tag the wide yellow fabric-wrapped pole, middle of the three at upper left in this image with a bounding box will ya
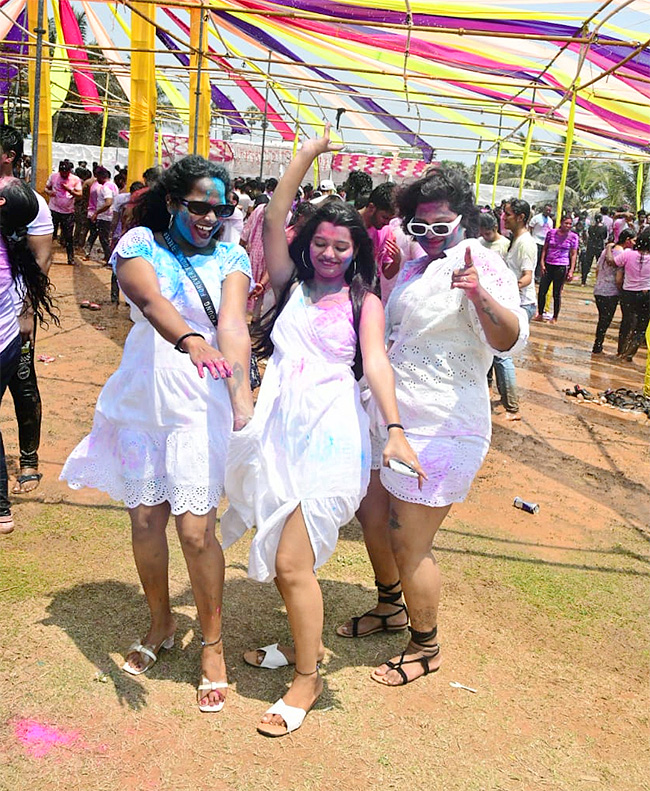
[129,2,157,180]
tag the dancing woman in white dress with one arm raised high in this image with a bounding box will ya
[221,127,420,736]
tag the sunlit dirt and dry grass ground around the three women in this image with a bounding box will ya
[0,254,650,791]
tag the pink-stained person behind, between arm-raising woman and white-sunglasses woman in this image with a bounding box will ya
[359,181,402,305]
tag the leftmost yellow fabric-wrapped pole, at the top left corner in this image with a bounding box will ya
[27,0,52,192]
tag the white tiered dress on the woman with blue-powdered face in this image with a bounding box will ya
[61,227,251,515]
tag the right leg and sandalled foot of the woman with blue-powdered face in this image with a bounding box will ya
[176,508,226,706]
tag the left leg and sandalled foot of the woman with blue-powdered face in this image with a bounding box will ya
[126,503,176,670]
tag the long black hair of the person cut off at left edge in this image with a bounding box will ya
[0,178,59,327]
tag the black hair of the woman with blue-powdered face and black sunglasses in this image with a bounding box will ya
[133,154,230,232]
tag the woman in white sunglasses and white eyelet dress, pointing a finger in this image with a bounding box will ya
[337,167,528,686]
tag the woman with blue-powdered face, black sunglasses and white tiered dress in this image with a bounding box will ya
[61,156,253,711]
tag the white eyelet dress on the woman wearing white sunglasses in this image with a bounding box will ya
[368,239,528,507]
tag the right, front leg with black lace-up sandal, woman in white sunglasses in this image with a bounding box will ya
[374,497,451,686]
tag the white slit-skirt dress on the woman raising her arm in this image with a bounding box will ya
[221,285,370,582]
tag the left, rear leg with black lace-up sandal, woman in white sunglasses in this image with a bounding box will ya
[337,470,408,637]
